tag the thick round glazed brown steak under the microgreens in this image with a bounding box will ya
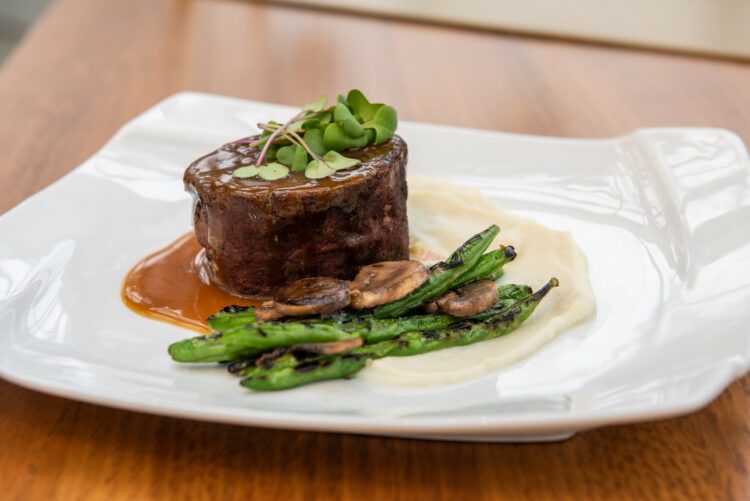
[184,136,409,297]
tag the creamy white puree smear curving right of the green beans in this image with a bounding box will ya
[357,177,596,386]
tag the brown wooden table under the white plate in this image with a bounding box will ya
[0,0,750,500]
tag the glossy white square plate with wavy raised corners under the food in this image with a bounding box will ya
[0,93,750,441]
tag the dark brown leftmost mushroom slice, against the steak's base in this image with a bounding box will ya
[255,277,349,321]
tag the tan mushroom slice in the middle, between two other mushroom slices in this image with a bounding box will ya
[349,260,429,310]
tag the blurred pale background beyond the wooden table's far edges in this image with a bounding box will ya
[0,0,750,61]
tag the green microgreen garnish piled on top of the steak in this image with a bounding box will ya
[233,89,398,181]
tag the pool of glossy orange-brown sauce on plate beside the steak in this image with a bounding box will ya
[121,232,261,333]
